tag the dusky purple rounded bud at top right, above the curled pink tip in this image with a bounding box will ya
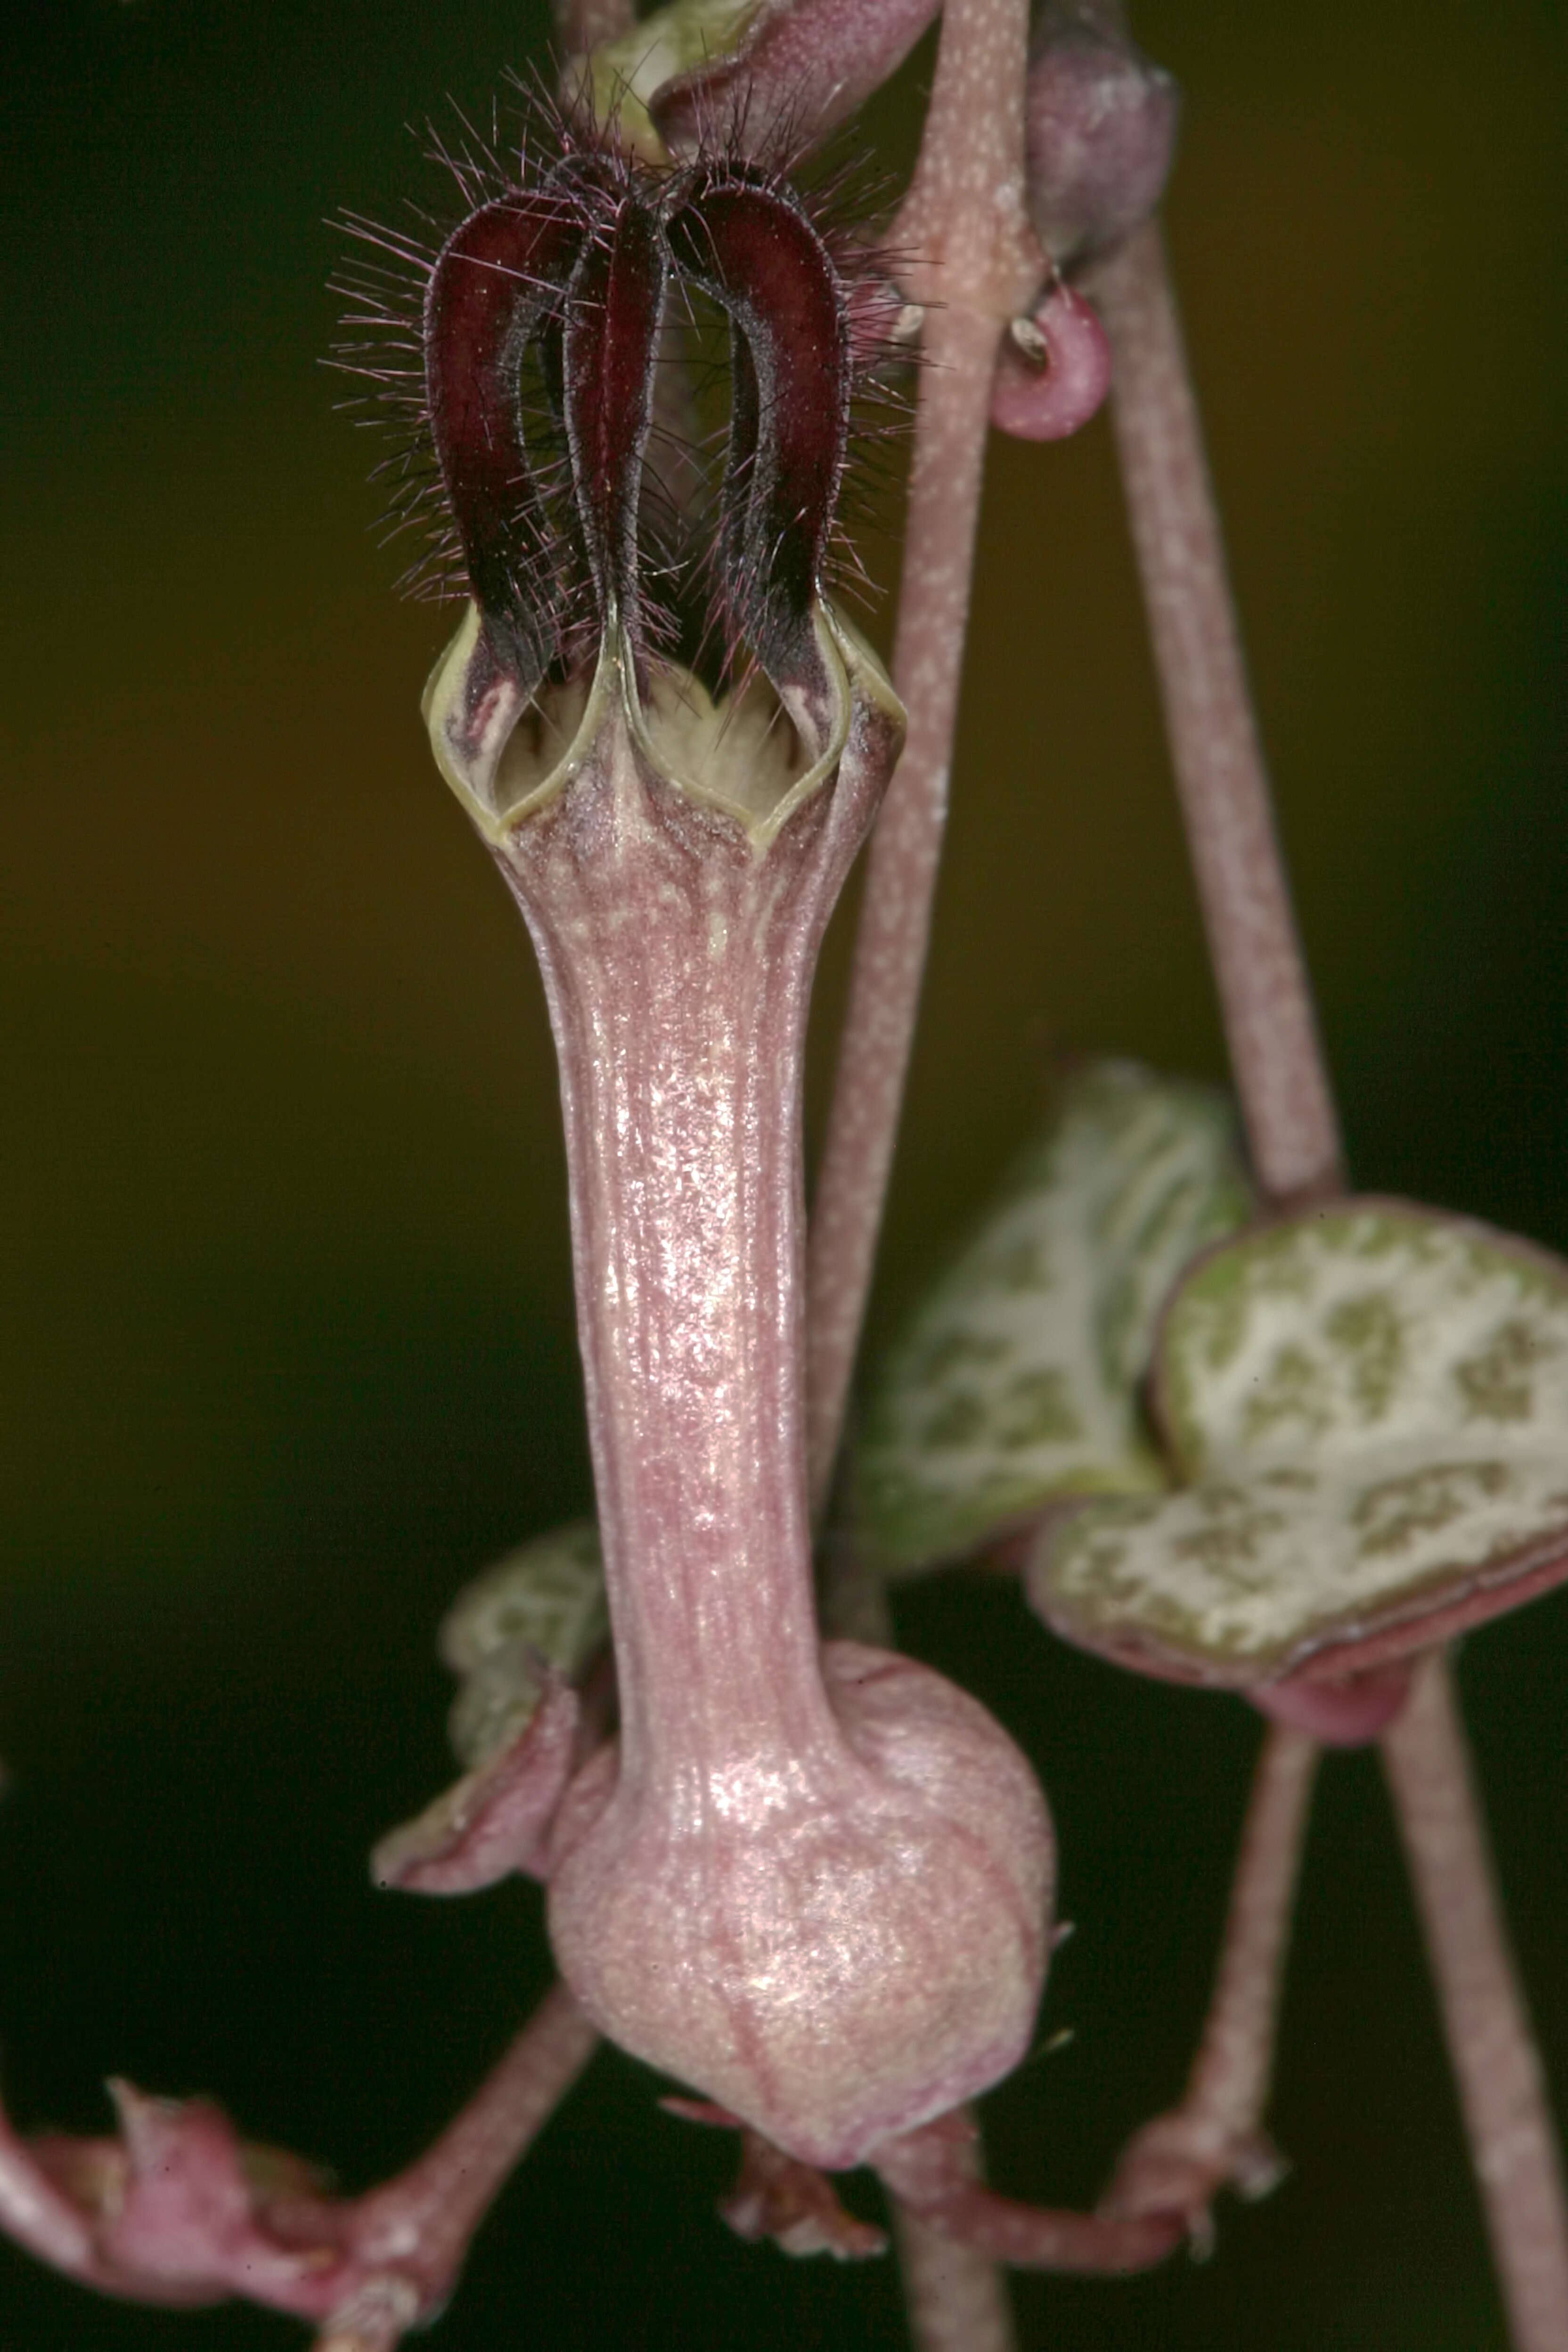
[1025,0,1180,266]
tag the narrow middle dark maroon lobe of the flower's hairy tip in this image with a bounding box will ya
[564,195,665,630]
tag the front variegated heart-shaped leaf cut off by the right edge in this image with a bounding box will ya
[1027,1200,1568,1686]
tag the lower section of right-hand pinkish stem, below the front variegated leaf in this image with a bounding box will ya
[1382,1651,1568,2352]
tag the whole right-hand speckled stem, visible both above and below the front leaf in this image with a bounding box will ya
[1093,212,1568,2352]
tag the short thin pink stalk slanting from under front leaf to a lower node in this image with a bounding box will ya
[1107,1724,1319,2248]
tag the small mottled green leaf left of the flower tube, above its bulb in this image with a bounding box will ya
[440,1519,609,1769]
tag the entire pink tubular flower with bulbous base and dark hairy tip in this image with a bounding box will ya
[425,129,1051,2169]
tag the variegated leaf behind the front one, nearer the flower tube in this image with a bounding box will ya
[853,1061,1248,1576]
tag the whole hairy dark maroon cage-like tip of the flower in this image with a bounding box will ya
[421,127,884,823]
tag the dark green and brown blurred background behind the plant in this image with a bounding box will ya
[0,0,1568,2352]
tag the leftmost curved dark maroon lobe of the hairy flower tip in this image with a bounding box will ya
[425,186,595,694]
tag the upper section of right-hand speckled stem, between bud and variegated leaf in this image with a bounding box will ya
[1093,223,1340,1204]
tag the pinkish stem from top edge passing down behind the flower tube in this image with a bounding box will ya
[806,0,1044,1515]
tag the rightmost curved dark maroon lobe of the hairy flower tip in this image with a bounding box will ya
[668,167,853,678]
